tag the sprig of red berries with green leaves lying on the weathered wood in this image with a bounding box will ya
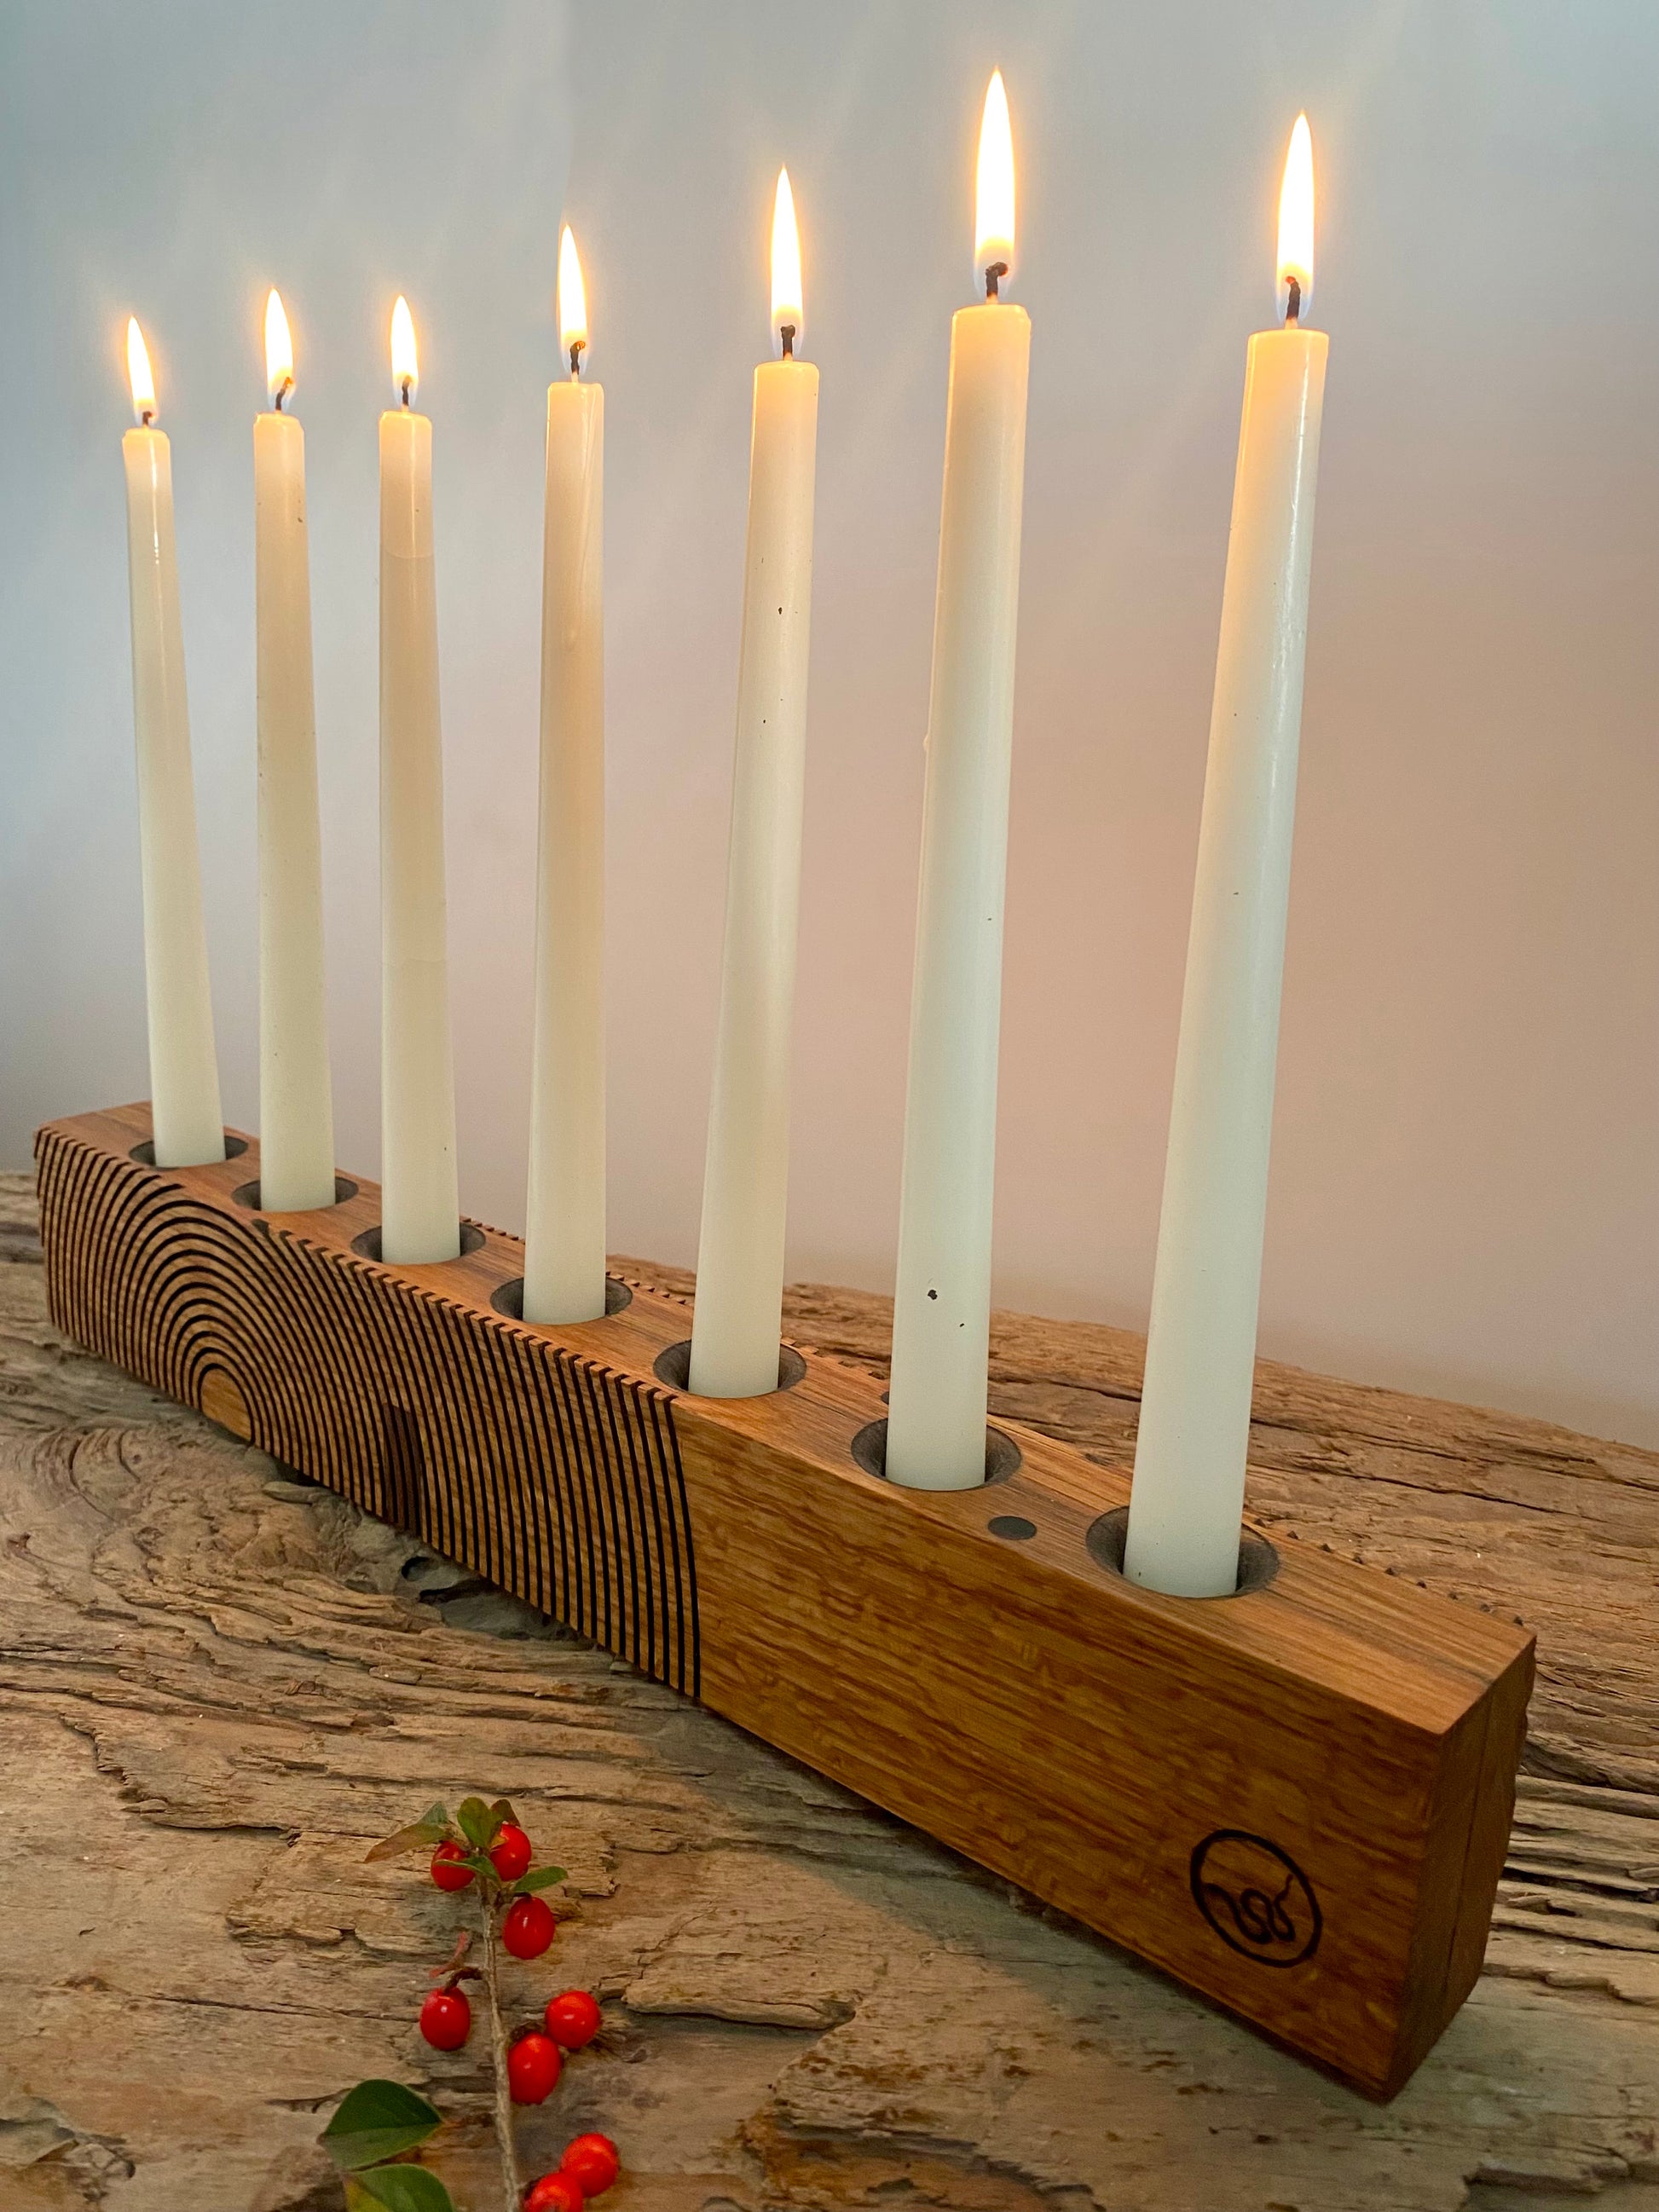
[323,1796,620,2212]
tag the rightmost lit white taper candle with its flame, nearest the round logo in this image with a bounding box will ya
[1124,115,1327,1597]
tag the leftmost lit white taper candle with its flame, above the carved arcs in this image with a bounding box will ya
[122,321,226,1168]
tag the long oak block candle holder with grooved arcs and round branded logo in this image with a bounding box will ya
[36,1106,1533,2097]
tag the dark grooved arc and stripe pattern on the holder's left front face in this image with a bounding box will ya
[38,1128,702,1696]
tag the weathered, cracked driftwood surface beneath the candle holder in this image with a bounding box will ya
[0,1177,1659,2212]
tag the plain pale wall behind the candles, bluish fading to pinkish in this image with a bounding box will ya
[0,0,1659,1442]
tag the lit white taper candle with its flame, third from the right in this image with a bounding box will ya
[691,170,818,1398]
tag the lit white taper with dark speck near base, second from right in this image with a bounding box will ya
[887,71,1031,1491]
